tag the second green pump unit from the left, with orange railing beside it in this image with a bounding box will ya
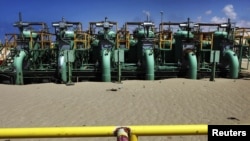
[52,18,90,85]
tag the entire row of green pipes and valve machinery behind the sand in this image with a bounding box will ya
[0,15,244,84]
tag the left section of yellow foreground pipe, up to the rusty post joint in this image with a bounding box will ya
[0,126,116,138]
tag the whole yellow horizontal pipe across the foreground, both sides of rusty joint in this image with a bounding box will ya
[0,125,208,141]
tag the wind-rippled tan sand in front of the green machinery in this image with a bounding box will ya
[0,62,250,141]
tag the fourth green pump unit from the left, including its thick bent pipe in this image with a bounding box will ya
[115,21,155,80]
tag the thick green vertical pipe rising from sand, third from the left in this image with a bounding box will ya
[101,50,111,82]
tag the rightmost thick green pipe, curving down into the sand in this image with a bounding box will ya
[223,49,239,79]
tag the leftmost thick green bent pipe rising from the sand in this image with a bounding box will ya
[14,50,26,85]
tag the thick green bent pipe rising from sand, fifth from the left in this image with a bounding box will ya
[187,52,197,79]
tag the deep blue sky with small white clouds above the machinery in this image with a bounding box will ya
[0,0,250,41]
